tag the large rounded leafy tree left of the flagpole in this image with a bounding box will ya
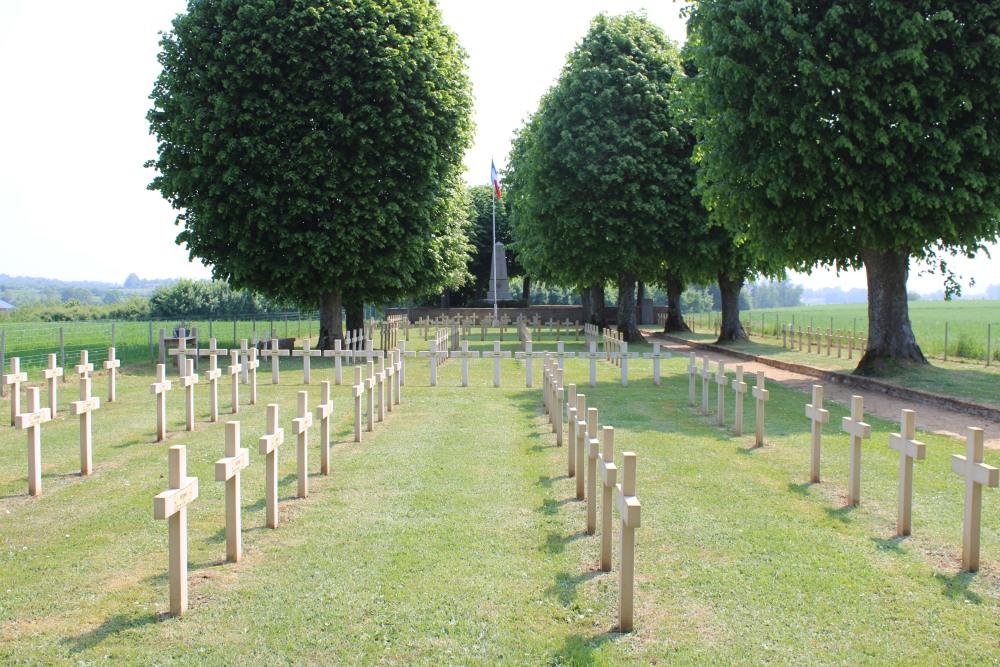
[148,0,472,346]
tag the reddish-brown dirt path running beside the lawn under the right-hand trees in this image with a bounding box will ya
[658,339,1000,450]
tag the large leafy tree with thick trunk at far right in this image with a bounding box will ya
[688,0,1000,373]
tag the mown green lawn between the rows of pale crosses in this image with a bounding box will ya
[0,336,1000,665]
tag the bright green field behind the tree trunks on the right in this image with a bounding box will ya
[691,300,1000,363]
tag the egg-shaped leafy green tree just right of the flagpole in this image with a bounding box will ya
[507,14,696,340]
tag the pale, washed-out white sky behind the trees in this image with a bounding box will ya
[0,0,1000,294]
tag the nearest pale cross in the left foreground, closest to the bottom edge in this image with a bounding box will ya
[153,446,198,616]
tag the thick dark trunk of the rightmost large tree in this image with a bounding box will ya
[854,248,928,375]
